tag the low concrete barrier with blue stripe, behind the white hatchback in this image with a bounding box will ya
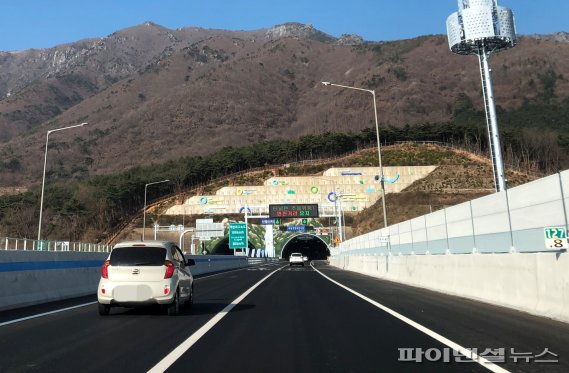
[0,251,253,311]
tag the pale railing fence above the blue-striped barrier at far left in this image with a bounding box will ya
[0,237,112,253]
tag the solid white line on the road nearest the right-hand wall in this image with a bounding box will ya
[312,266,509,373]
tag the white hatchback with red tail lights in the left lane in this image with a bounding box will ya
[97,241,195,315]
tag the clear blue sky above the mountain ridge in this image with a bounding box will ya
[0,0,569,51]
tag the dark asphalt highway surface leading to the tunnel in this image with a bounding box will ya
[0,262,569,372]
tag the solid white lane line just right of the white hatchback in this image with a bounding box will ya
[148,266,286,373]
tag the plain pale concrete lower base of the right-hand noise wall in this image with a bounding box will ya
[330,253,569,322]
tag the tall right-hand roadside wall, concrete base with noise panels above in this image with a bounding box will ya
[331,170,569,322]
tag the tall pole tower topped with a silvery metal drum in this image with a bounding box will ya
[447,0,516,192]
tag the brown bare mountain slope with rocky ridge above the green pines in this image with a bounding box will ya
[0,22,569,186]
